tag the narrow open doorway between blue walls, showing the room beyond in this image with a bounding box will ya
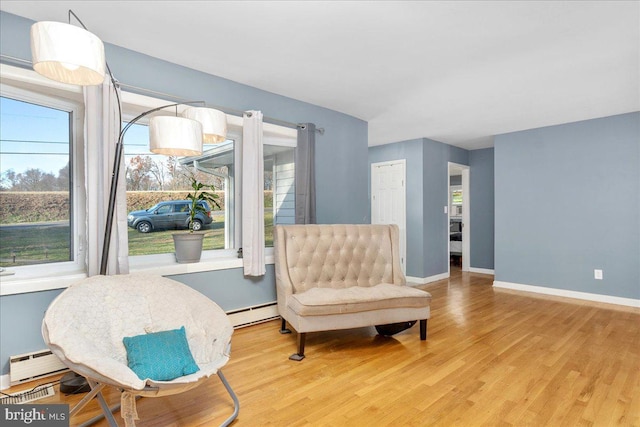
[446,162,471,274]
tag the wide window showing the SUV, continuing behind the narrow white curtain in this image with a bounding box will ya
[123,93,297,256]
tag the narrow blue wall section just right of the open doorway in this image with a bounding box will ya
[469,148,495,270]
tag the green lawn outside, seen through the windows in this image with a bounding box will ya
[0,210,273,267]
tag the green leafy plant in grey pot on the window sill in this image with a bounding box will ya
[173,175,220,264]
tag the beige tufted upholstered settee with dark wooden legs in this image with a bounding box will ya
[274,224,431,360]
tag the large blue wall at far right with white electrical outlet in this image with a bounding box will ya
[495,113,640,299]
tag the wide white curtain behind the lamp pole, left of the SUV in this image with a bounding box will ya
[84,80,129,276]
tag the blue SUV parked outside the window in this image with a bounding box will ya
[127,200,212,233]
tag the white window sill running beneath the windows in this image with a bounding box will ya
[0,248,274,296]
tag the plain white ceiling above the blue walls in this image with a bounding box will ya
[0,0,640,149]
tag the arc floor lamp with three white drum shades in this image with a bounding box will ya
[31,10,227,275]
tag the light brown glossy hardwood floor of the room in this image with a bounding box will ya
[10,270,640,427]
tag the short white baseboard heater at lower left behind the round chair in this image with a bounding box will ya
[9,350,68,385]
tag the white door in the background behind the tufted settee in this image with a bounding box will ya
[371,159,407,273]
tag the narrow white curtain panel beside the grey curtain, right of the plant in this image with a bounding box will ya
[242,111,266,276]
